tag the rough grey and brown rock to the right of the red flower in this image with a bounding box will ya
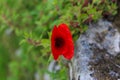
[69,20,120,80]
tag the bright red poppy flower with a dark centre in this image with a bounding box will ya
[51,24,74,60]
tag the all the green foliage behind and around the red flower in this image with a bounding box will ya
[0,0,117,80]
